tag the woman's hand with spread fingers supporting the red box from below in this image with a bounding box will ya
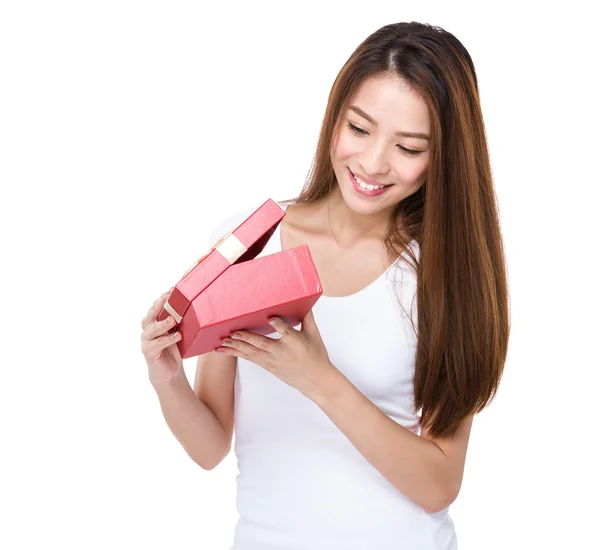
[216,310,340,400]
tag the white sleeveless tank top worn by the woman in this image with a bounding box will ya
[204,203,457,550]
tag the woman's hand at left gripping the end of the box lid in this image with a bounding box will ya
[141,290,184,383]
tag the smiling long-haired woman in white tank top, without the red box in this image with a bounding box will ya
[142,22,509,550]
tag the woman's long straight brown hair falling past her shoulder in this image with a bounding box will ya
[283,22,510,437]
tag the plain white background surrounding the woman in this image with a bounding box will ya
[0,0,600,550]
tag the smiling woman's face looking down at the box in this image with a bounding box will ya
[331,76,430,214]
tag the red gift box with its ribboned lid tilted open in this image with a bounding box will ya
[158,199,323,359]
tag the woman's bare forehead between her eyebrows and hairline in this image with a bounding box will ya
[348,75,430,133]
